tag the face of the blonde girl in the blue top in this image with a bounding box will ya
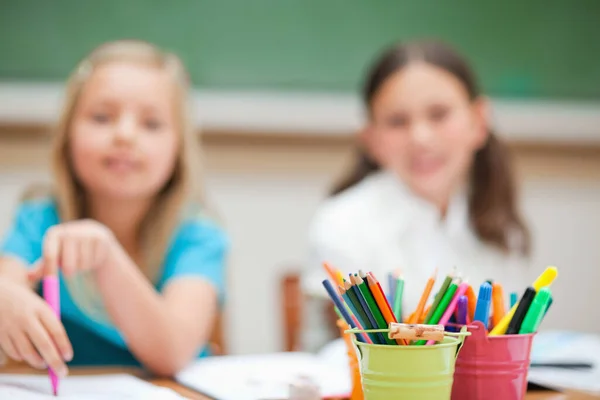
[70,62,180,203]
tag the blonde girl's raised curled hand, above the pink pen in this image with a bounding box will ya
[29,220,122,280]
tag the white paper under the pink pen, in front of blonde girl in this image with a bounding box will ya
[0,374,183,400]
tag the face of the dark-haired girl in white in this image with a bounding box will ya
[363,63,487,204]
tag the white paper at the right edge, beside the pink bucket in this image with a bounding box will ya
[527,331,600,394]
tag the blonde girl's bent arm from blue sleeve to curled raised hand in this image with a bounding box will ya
[30,220,226,375]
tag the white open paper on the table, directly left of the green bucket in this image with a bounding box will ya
[176,352,351,400]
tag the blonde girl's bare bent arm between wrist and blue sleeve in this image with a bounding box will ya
[96,248,218,376]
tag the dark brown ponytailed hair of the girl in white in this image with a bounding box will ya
[332,41,530,255]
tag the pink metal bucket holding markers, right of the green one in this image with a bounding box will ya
[452,321,534,400]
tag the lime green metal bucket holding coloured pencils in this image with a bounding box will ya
[348,329,470,400]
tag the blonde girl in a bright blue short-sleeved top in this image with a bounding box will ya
[0,41,228,376]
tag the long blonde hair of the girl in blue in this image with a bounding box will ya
[46,40,202,320]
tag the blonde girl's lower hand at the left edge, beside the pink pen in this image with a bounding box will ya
[0,281,73,377]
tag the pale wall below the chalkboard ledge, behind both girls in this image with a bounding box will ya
[0,140,600,353]
